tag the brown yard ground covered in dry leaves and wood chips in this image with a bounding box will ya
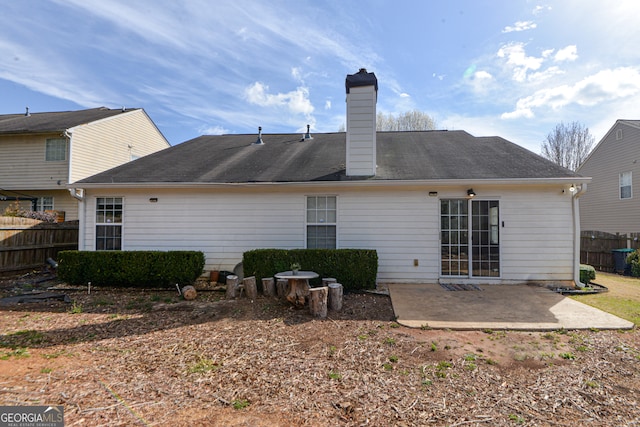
[0,272,640,426]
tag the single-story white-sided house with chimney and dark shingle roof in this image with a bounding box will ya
[74,70,588,283]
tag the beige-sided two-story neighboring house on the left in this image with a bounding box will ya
[0,107,169,220]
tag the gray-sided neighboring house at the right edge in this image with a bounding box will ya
[577,120,640,233]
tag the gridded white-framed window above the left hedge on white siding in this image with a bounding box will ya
[96,197,123,251]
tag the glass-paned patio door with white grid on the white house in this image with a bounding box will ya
[440,199,500,277]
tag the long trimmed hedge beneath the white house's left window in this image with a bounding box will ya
[58,251,205,287]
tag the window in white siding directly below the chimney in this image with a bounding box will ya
[307,196,337,249]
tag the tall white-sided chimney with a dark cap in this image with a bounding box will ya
[345,68,378,176]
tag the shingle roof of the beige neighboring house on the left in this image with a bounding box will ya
[0,107,137,134]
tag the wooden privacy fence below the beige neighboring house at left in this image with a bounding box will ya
[0,217,78,274]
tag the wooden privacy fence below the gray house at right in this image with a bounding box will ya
[580,231,640,272]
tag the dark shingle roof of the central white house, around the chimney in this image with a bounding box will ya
[80,131,579,184]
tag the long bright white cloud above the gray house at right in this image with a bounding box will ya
[501,67,640,119]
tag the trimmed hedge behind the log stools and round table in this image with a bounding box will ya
[242,249,378,290]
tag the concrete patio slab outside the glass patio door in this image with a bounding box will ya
[388,284,634,331]
